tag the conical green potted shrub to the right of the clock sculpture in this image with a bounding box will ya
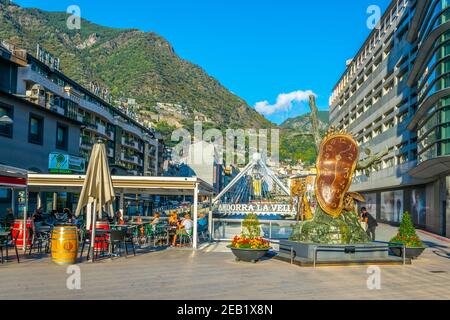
[391,212,425,259]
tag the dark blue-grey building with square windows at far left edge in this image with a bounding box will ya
[0,42,82,174]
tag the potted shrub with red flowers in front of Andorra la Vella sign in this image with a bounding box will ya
[229,214,271,263]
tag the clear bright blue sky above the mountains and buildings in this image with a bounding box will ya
[14,0,390,123]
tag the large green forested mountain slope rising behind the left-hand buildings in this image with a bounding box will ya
[0,0,273,129]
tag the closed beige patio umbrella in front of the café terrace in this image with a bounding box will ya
[75,141,115,261]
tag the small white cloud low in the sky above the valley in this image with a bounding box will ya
[255,90,315,116]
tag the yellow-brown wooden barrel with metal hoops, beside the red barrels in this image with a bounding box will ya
[52,226,78,265]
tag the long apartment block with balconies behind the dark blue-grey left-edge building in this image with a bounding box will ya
[3,43,163,176]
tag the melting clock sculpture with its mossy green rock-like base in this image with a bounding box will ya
[290,128,381,244]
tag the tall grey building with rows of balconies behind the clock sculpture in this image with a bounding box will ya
[330,0,450,236]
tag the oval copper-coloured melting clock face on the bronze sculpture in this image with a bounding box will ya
[315,133,359,218]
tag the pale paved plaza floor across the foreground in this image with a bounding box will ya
[0,226,450,300]
